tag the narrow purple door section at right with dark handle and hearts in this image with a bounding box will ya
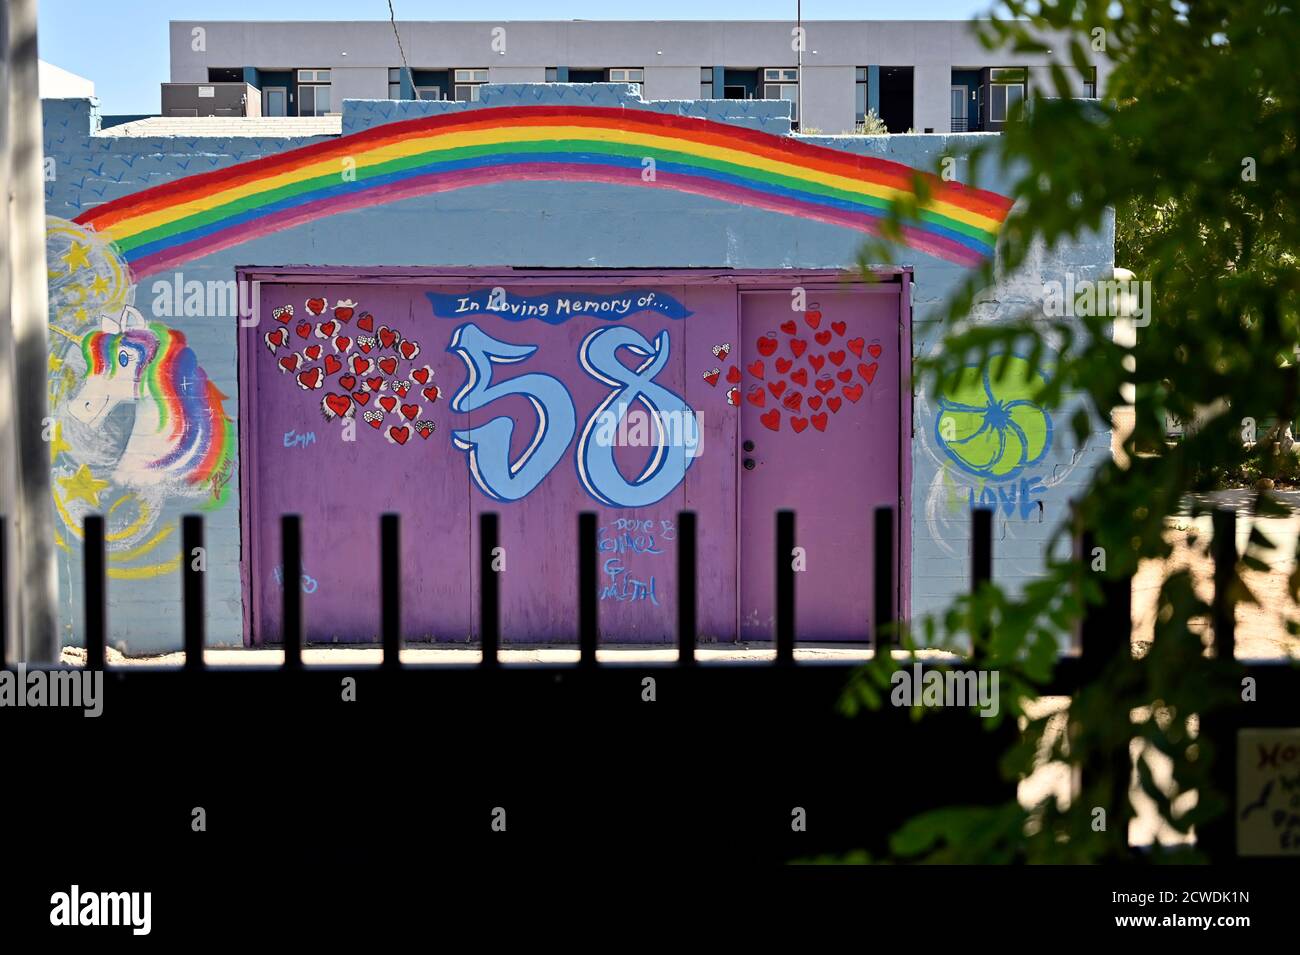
[740,283,901,641]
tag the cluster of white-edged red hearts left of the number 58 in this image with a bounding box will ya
[263,298,442,444]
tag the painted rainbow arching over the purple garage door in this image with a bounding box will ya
[75,107,1011,279]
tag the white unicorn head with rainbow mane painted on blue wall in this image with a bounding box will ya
[66,307,234,507]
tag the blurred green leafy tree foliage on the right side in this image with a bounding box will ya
[842,0,1300,861]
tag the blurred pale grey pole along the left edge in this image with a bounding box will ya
[0,0,60,663]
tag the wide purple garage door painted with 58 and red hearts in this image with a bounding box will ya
[241,274,898,643]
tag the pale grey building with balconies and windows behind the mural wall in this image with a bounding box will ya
[163,21,1108,134]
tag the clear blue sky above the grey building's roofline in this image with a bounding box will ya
[39,0,992,113]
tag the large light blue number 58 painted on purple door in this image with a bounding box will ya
[447,322,701,507]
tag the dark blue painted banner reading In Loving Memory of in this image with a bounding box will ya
[425,288,693,325]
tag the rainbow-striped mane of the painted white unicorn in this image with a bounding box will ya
[82,322,234,504]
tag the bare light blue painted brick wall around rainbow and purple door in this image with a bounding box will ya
[43,84,1114,652]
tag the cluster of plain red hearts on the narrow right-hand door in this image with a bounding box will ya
[705,311,880,434]
